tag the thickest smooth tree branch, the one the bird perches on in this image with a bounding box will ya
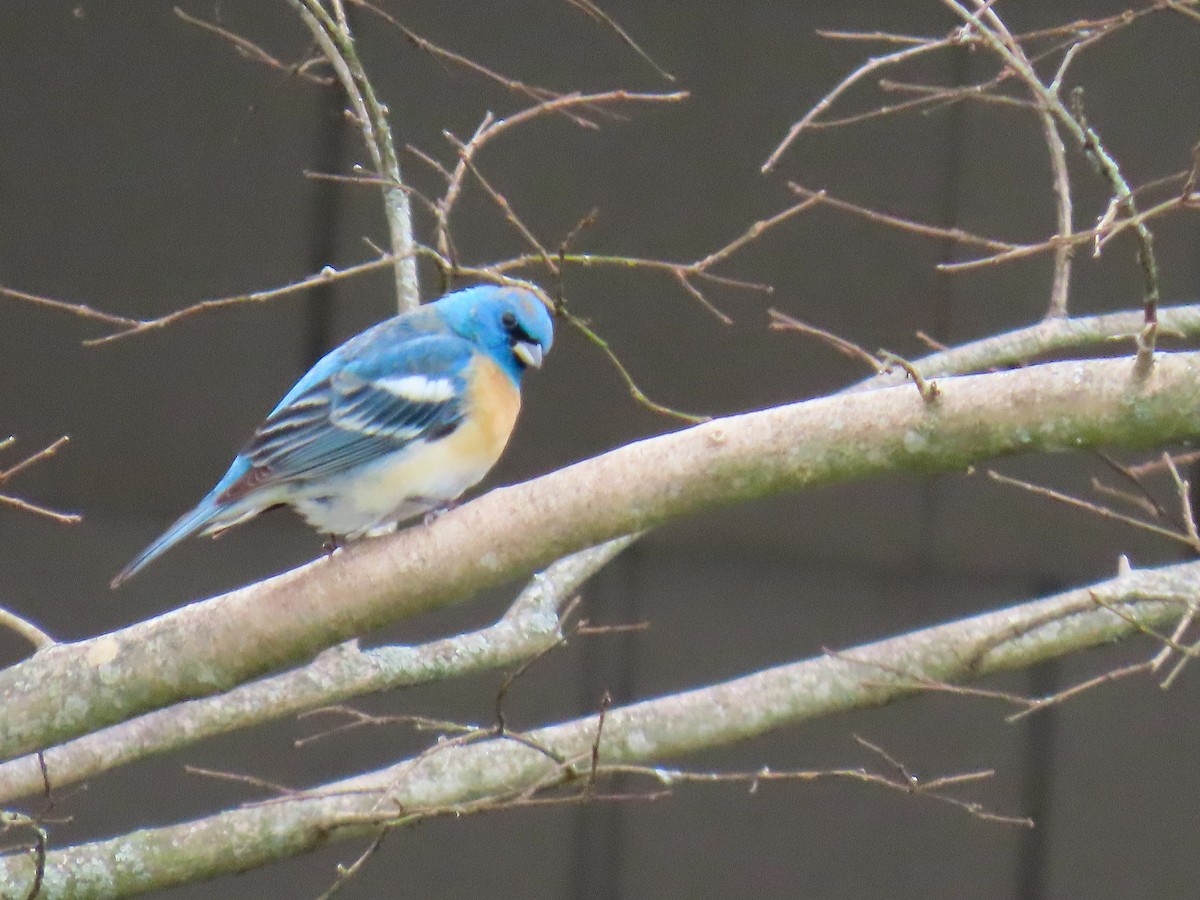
[0,353,1200,758]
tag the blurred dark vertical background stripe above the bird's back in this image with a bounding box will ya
[304,84,347,368]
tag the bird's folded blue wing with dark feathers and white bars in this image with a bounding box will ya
[226,334,474,499]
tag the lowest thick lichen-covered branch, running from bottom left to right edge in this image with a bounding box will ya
[0,563,1200,900]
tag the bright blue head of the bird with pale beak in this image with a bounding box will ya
[432,284,554,383]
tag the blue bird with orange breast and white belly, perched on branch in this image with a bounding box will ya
[113,286,554,588]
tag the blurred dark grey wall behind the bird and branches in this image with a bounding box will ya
[0,0,1200,900]
